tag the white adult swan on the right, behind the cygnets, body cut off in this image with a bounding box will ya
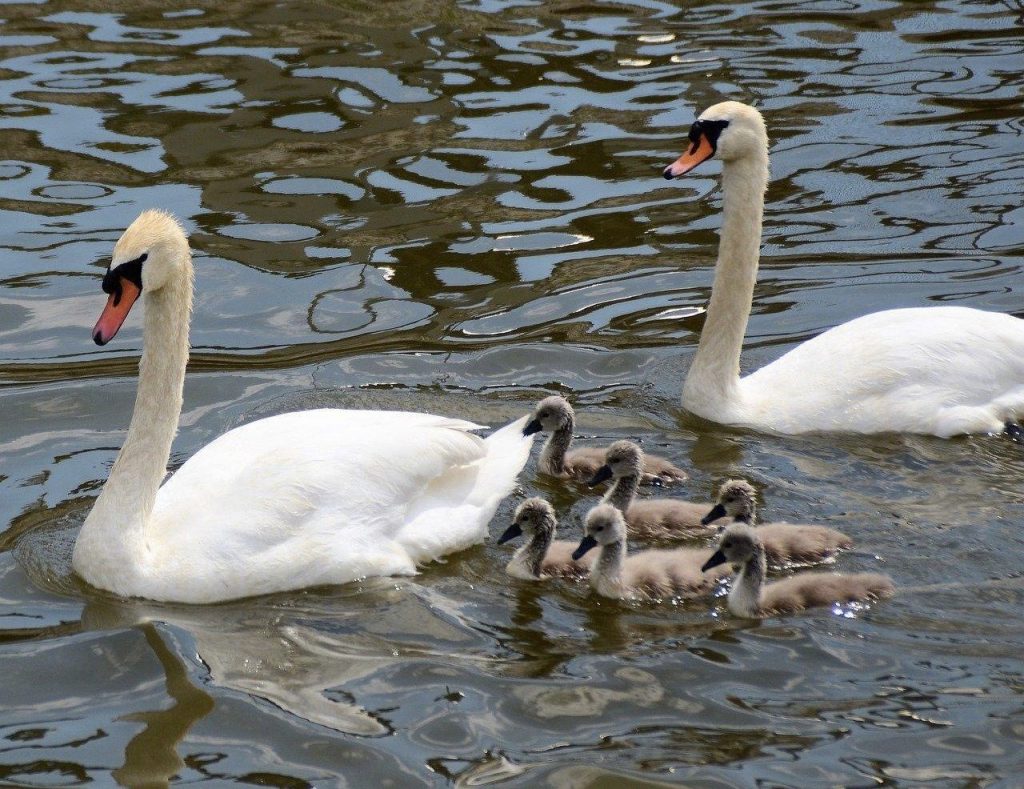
[665,101,1024,437]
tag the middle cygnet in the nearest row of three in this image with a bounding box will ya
[572,503,727,600]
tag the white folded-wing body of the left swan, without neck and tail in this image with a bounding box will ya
[146,409,507,601]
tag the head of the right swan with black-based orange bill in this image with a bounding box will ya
[665,101,768,179]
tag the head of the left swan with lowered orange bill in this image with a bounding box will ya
[92,209,189,345]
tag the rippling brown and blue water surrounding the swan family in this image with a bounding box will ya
[0,0,1024,786]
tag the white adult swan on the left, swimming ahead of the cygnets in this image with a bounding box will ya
[73,211,531,603]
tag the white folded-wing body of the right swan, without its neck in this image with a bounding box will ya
[740,307,1024,436]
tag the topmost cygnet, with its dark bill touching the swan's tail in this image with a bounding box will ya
[522,395,687,485]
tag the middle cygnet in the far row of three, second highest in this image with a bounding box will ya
[587,441,725,539]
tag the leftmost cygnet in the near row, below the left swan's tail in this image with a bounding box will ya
[498,497,594,580]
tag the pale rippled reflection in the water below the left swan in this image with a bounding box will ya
[15,518,423,742]
